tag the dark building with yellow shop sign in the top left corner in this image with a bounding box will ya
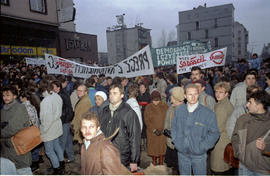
[0,0,59,63]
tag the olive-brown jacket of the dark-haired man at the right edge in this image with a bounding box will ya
[232,113,270,174]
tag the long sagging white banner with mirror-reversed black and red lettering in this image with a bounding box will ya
[45,46,154,78]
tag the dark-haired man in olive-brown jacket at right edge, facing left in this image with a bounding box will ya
[232,91,270,175]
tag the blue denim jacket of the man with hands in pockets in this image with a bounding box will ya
[171,104,219,156]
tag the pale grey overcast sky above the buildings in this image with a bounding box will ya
[74,0,270,54]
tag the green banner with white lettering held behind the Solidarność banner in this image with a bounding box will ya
[151,40,211,67]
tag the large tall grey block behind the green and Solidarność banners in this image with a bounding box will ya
[177,4,234,64]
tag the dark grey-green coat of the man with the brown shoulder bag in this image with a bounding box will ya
[1,100,32,169]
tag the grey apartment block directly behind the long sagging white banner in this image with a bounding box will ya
[106,25,152,64]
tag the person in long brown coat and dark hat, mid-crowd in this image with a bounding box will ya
[144,90,168,165]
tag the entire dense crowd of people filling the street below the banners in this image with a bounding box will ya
[0,54,270,175]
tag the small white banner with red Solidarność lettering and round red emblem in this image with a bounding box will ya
[176,48,227,74]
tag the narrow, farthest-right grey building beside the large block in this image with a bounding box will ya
[233,21,248,61]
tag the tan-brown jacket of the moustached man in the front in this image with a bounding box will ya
[81,130,128,175]
